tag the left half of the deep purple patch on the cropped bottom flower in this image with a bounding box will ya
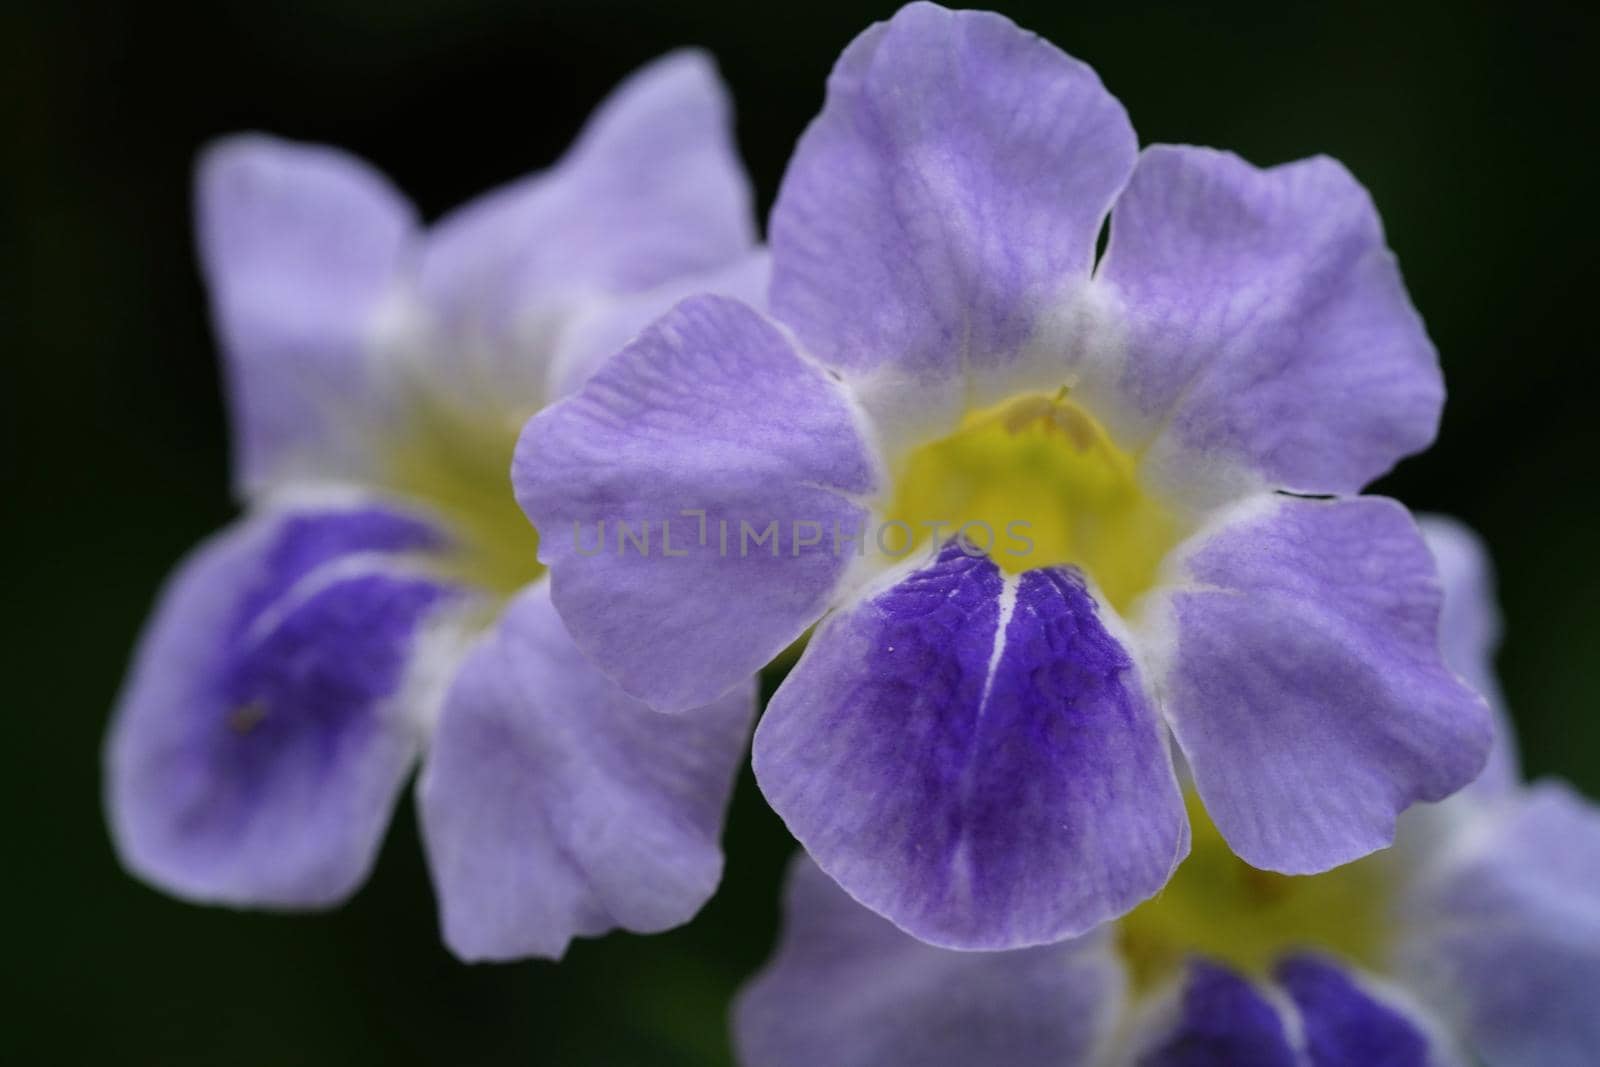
[1131,960,1301,1067]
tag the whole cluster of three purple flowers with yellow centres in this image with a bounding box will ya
[106,3,1600,1067]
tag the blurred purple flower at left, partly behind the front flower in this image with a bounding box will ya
[106,53,765,958]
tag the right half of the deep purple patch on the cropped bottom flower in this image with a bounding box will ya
[1274,955,1434,1067]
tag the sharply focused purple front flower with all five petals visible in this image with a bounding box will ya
[514,3,1491,949]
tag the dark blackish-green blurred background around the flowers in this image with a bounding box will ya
[0,0,1600,1067]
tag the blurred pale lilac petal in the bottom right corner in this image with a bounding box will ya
[1400,782,1600,1067]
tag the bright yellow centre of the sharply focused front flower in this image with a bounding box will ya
[885,389,1187,611]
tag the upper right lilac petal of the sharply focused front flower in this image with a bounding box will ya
[1096,146,1445,493]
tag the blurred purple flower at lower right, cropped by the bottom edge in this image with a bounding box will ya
[734,520,1600,1067]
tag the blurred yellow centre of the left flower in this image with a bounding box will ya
[384,400,544,595]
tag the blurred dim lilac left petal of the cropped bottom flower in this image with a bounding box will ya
[733,856,1126,1067]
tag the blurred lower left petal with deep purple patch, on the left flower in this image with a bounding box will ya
[106,507,453,907]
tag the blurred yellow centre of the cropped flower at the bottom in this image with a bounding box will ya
[1117,793,1390,989]
